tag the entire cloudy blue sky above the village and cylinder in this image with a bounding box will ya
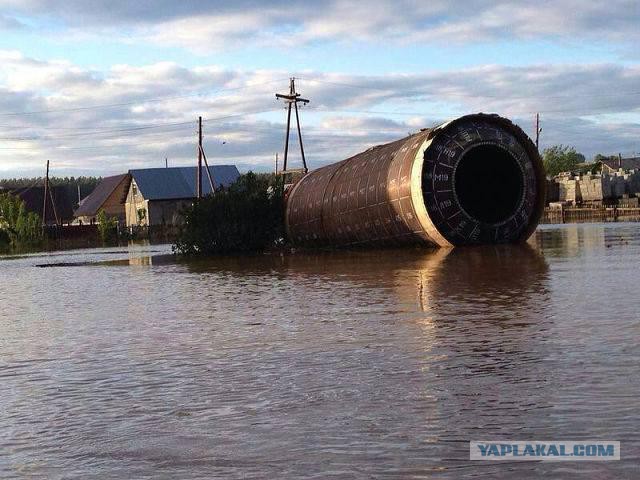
[0,0,640,178]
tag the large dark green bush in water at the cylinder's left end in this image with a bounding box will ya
[174,172,284,255]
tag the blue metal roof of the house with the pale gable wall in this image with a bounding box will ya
[129,165,240,200]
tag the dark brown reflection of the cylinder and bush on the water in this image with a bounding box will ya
[181,244,547,320]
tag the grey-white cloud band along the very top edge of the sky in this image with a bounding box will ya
[0,0,640,52]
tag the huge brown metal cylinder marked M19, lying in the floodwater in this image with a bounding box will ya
[286,113,545,247]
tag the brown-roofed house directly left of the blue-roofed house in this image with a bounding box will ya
[74,173,131,224]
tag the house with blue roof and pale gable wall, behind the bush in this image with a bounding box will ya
[125,165,240,226]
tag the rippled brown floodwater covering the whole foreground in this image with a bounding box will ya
[0,224,640,479]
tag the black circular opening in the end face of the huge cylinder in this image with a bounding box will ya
[455,145,524,224]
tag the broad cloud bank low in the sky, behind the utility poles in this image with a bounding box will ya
[0,51,640,177]
